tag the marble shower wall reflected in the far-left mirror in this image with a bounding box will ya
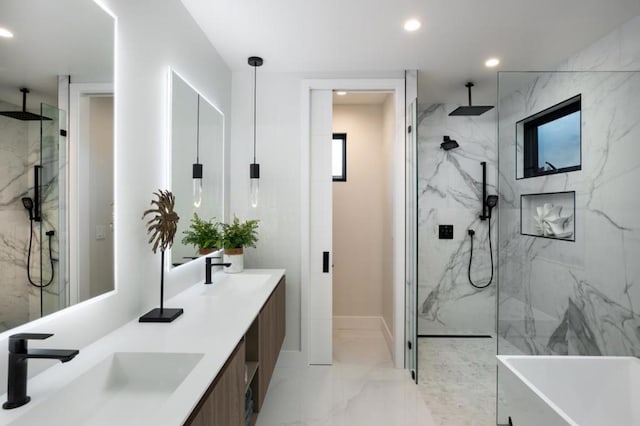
[0,101,66,332]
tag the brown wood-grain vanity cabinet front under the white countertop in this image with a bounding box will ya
[185,277,285,426]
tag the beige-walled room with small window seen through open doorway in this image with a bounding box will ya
[332,91,395,365]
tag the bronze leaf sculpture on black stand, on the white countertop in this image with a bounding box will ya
[138,189,184,322]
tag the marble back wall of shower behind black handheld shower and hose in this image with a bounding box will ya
[418,104,497,335]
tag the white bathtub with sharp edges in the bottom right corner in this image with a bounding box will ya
[498,356,640,426]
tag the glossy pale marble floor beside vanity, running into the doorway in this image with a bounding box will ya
[257,330,437,426]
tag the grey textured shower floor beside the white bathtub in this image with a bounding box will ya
[418,337,497,426]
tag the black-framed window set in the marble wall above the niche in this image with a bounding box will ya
[516,95,582,178]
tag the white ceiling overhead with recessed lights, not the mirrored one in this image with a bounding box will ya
[181,0,640,104]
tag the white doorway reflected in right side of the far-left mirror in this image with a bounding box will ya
[69,83,114,304]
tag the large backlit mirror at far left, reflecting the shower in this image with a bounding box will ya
[0,0,115,332]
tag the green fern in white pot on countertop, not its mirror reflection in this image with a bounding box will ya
[220,216,258,273]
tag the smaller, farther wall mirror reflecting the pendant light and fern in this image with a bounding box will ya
[169,71,224,266]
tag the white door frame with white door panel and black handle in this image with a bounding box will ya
[301,79,405,368]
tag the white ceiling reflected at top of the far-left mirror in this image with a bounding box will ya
[0,0,115,110]
